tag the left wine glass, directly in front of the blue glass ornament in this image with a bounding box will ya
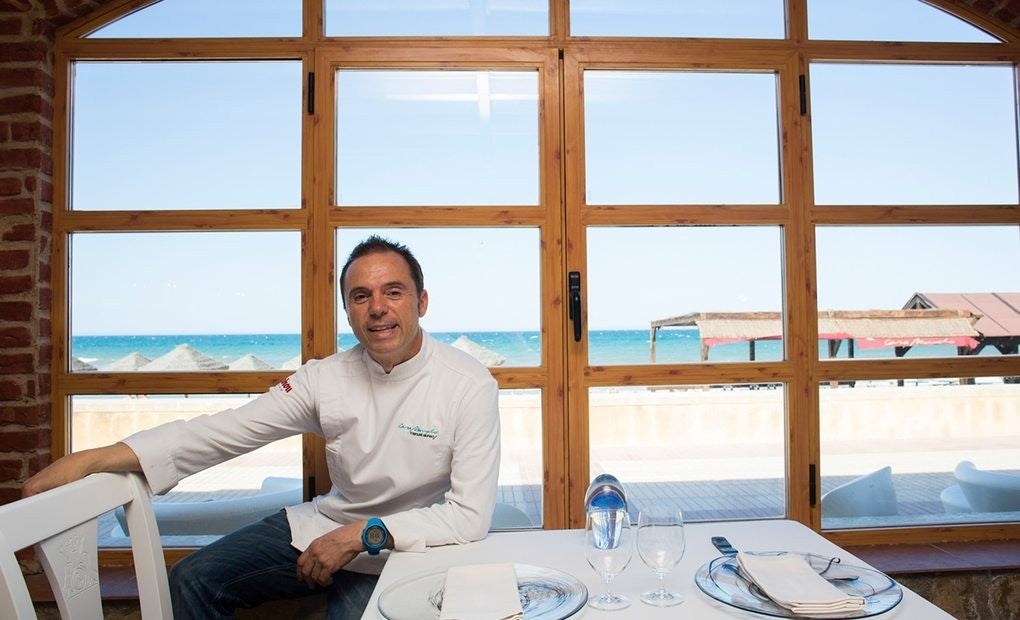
[584,509,633,611]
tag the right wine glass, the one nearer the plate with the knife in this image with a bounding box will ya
[638,504,685,607]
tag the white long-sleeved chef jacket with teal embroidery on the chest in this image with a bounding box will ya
[124,333,500,573]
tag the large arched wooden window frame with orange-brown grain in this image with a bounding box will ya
[52,0,1020,562]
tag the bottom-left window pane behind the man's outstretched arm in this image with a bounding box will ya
[70,394,302,547]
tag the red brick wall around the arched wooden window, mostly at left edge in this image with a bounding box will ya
[0,0,1020,504]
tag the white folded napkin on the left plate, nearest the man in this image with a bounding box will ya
[440,564,524,620]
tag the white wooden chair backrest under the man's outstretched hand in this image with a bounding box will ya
[0,473,172,620]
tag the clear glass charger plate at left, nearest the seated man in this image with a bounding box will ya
[378,564,588,620]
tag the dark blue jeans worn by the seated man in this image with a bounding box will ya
[169,510,378,620]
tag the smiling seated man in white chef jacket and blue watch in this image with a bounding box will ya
[24,236,500,620]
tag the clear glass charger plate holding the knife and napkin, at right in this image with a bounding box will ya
[695,551,903,620]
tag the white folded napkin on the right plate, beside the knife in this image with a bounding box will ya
[736,552,867,615]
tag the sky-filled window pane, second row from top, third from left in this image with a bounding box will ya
[584,70,780,205]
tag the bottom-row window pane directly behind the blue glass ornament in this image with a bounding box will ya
[589,385,786,521]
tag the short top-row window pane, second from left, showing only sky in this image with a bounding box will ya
[325,0,549,37]
